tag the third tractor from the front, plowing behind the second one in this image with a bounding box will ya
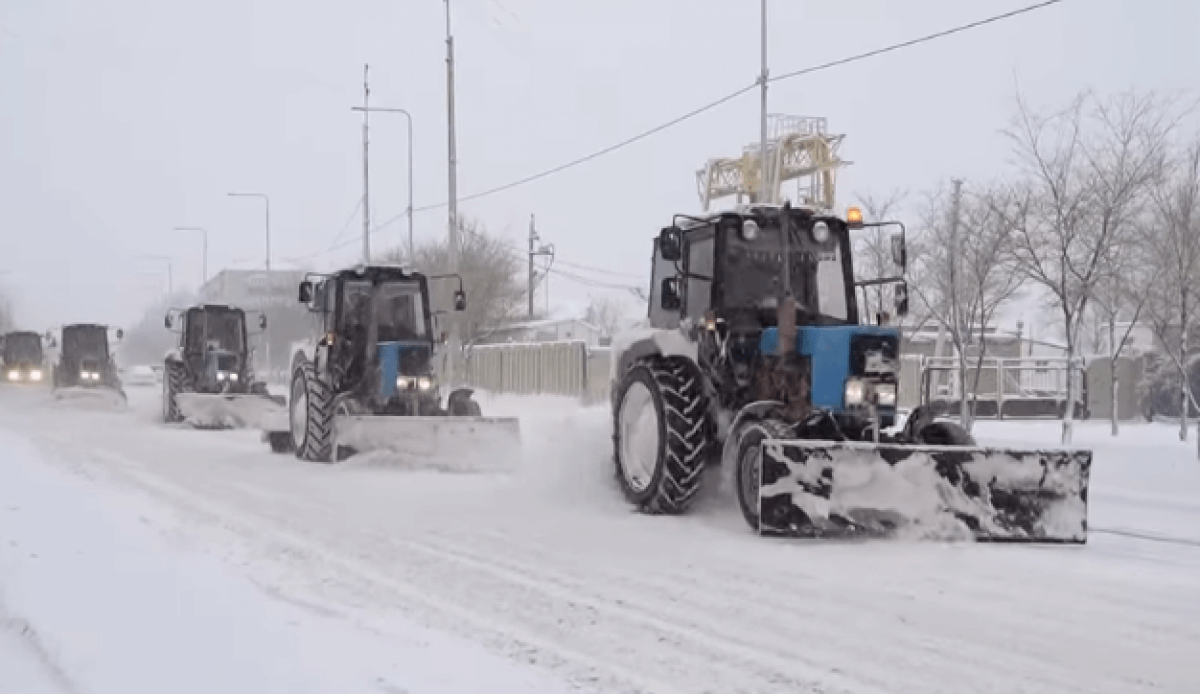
[162,304,287,429]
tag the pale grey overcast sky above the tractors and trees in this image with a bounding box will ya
[0,0,1200,329]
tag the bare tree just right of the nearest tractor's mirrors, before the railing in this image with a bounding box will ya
[914,180,1020,431]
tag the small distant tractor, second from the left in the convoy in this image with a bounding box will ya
[54,323,126,405]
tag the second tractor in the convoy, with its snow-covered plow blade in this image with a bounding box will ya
[266,265,520,468]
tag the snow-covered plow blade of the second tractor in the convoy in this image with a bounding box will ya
[335,415,521,472]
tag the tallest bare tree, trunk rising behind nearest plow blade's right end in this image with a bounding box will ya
[1007,88,1178,444]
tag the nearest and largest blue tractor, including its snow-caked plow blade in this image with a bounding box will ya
[612,204,1091,542]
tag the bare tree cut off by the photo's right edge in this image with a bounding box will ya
[1147,138,1200,450]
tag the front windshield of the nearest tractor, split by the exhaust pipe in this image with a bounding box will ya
[725,229,850,323]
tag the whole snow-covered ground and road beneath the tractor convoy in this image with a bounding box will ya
[0,388,1200,694]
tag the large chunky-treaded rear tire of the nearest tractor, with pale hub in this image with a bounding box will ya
[613,358,709,515]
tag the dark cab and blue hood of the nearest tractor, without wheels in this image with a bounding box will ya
[649,205,907,429]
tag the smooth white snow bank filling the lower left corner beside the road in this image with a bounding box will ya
[0,431,566,694]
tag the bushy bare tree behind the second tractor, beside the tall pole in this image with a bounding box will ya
[386,216,526,345]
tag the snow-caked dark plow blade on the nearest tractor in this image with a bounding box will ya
[758,439,1092,544]
